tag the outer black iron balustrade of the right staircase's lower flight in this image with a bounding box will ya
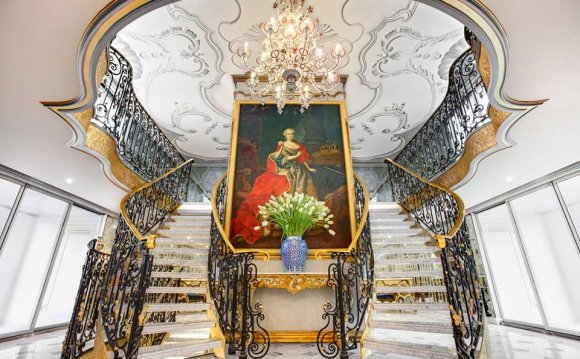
[385,159,485,358]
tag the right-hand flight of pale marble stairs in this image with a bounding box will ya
[361,203,457,359]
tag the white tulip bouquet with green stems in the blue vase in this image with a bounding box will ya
[254,192,335,237]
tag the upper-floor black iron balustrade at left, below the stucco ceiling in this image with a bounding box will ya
[91,47,185,181]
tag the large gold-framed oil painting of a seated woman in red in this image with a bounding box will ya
[224,101,356,253]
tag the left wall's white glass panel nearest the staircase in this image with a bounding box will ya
[35,207,102,328]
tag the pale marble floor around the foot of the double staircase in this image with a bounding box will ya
[0,325,580,359]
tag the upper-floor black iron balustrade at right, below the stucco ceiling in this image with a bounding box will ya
[395,50,491,180]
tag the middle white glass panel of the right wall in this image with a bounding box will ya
[511,187,580,333]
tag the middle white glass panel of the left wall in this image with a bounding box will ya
[0,189,68,336]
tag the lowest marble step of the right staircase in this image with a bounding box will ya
[363,340,457,359]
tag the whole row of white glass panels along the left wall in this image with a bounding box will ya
[0,177,107,338]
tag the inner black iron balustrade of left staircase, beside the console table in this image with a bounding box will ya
[208,176,270,359]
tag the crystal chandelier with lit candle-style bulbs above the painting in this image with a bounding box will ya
[237,0,346,113]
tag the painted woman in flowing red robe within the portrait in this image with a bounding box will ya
[232,128,318,244]
